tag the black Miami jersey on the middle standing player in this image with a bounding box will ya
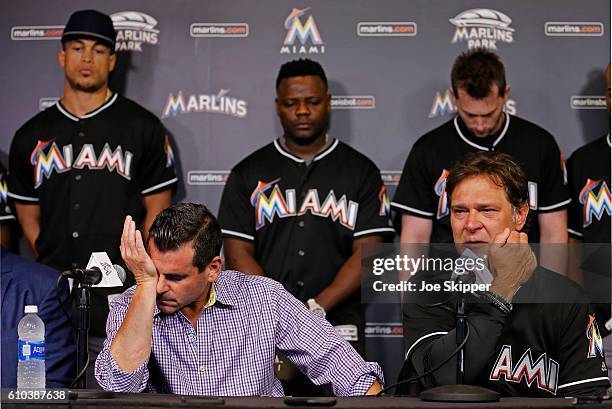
[219,140,394,330]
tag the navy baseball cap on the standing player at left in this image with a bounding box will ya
[62,10,117,53]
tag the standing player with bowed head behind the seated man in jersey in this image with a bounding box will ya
[391,49,570,268]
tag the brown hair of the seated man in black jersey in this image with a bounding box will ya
[446,152,529,209]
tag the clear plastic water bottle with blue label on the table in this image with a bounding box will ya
[17,305,45,389]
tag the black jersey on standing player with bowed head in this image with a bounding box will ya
[391,114,570,243]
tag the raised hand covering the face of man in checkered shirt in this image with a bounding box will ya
[119,216,158,286]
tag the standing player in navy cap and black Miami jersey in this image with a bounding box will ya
[9,10,177,386]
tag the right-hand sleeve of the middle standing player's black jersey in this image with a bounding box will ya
[353,159,395,238]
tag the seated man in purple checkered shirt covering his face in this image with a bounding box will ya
[96,203,382,396]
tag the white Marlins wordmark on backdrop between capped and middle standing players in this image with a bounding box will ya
[162,88,247,118]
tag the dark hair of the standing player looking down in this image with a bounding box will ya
[451,48,506,99]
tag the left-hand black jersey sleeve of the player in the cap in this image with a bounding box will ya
[8,131,38,204]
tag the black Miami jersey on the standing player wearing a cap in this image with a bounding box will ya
[9,94,177,336]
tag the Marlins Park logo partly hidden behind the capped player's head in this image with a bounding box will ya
[111,11,159,52]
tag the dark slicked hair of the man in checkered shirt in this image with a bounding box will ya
[148,203,222,271]
